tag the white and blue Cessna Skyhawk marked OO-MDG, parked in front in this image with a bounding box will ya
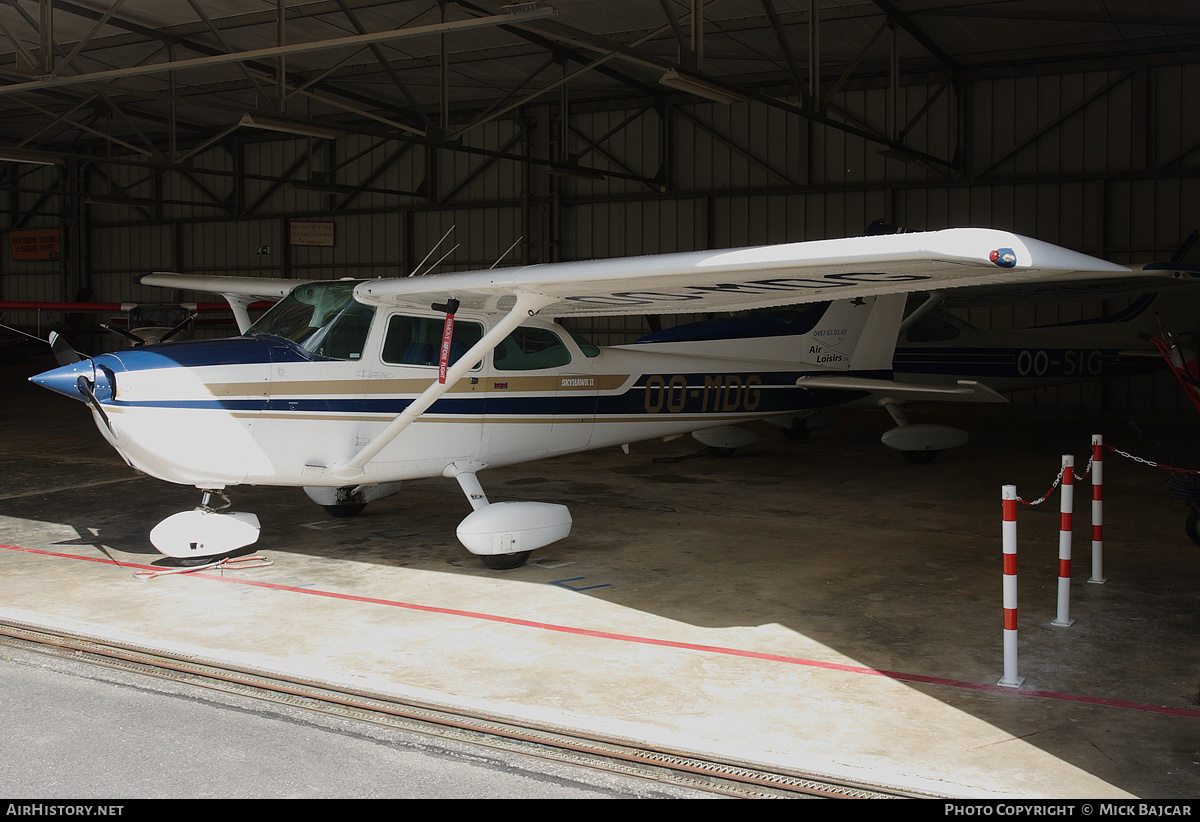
[32,229,1129,569]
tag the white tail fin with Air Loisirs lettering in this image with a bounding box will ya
[635,294,907,371]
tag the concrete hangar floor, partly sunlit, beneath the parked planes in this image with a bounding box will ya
[0,366,1200,798]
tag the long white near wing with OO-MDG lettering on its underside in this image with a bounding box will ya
[355,228,1129,317]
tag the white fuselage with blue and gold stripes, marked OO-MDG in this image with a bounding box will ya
[56,306,868,488]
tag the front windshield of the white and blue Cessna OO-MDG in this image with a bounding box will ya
[246,280,374,360]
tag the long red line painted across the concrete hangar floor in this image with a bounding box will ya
[9,545,1200,719]
